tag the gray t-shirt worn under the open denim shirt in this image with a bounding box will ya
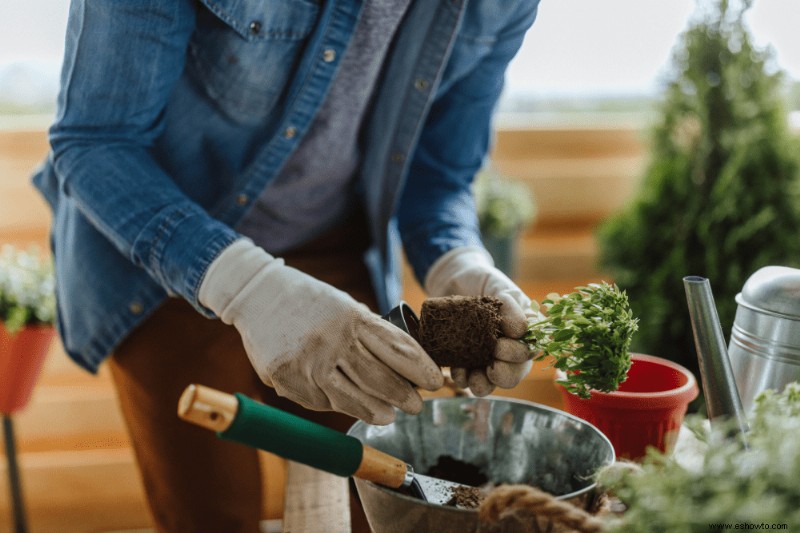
[236,0,411,253]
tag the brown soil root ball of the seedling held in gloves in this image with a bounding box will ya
[419,296,503,369]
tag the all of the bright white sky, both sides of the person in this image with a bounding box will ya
[0,0,800,100]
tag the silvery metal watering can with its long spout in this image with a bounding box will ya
[683,266,800,429]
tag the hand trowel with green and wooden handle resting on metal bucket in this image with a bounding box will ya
[178,385,476,505]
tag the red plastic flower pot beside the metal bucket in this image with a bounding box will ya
[558,354,698,460]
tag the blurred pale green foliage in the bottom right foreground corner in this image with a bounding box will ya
[598,383,800,533]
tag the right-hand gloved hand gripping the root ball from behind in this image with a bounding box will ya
[424,247,535,396]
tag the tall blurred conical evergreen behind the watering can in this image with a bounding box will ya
[598,0,800,384]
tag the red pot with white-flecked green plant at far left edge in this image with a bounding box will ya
[0,245,55,414]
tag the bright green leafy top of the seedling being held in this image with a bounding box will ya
[524,282,638,398]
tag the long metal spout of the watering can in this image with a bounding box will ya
[683,276,748,434]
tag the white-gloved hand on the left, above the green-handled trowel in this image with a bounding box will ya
[198,239,444,424]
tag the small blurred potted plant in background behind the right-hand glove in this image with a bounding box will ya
[473,166,536,277]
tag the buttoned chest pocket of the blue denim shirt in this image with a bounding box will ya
[187,0,319,123]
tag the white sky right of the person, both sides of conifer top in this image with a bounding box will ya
[507,0,800,95]
